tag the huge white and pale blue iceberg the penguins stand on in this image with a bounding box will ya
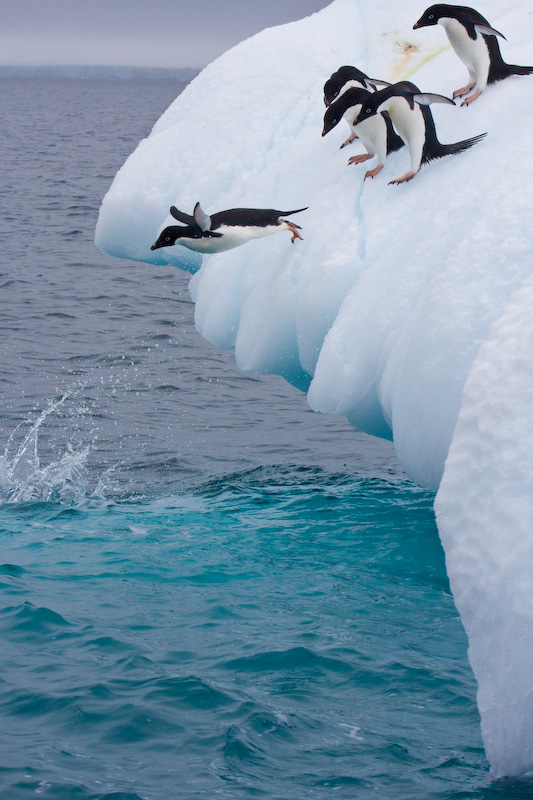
[96,0,533,776]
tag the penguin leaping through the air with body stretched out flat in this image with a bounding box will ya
[150,203,307,253]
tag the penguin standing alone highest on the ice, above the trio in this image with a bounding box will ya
[413,3,533,106]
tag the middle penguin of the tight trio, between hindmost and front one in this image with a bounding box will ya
[322,87,403,180]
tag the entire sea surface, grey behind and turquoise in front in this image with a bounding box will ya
[0,75,532,800]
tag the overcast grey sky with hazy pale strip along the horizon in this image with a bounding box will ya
[0,0,331,67]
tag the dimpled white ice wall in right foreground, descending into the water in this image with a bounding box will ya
[435,275,533,775]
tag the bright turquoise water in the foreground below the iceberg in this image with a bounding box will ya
[0,467,486,799]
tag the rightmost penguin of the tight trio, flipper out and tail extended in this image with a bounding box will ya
[354,81,486,183]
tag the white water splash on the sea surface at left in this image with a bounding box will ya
[0,393,90,506]
